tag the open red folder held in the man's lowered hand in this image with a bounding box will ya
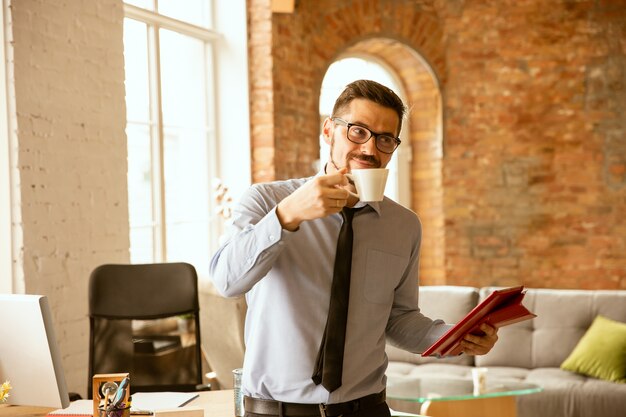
[422,286,537,356]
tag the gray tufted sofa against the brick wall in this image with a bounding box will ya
[387,286,626,417]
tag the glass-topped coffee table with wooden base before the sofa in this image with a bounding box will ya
[387,376,542,417]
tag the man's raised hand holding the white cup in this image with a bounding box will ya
[276,168,350,231]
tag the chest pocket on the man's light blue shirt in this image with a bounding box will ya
[363,249,407,304]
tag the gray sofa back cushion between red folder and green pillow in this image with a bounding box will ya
[475,287,626,368]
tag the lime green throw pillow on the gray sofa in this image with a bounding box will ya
[561,316,626,383]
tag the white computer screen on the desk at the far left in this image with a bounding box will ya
[0,294,70,408]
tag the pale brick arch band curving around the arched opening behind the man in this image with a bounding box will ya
[319,37,445,285]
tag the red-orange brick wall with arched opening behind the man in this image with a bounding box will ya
[248,0,626,288]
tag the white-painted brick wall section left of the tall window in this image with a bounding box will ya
[9,0,129,396]
